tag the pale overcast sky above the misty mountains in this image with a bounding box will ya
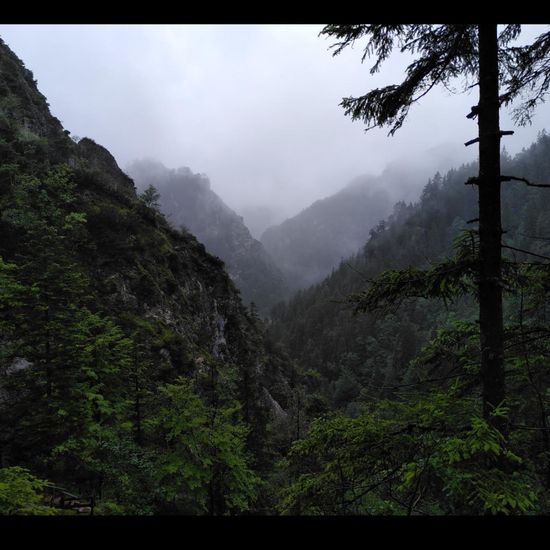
[0,25,550,222]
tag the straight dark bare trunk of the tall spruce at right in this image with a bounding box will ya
[478,24,505,431]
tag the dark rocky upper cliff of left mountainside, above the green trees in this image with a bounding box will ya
[0,36,270,376]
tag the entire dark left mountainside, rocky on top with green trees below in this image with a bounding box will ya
[0,36,298,514]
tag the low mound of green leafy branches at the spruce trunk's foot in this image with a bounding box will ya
[280,384,537,515]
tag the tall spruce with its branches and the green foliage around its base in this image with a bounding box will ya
[264,23,550,515]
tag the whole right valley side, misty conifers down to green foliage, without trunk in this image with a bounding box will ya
[270,134,550,514]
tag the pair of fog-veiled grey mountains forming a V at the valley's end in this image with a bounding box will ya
[126,146,464,304]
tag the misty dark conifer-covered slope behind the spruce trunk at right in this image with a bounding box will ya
[270,135,550,413]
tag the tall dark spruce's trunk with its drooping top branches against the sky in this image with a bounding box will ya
[321,24,550,430]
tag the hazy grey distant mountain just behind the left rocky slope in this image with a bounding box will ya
[126,160,286,313]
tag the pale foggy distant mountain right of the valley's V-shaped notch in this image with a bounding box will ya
[261,176,392,290]
